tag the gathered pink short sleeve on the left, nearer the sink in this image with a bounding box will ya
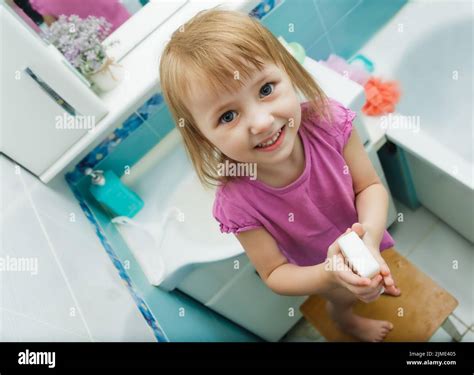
[212,191,263,233]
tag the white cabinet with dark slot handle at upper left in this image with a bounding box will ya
[0,4,107,176]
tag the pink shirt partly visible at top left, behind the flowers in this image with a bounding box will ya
[30,0,130,32]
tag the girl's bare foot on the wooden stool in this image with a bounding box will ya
[326,301,393,342]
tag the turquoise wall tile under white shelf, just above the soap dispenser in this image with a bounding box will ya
[95,124,158,176]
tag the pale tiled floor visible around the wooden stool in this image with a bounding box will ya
[282,202,474,342]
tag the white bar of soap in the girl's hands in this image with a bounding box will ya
[337,232,380,279]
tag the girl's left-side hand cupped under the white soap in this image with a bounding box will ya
[325,228,383,303]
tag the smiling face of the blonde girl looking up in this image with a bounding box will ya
[188,64,301,167]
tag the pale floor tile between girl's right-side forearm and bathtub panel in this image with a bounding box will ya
[388,200,438,256]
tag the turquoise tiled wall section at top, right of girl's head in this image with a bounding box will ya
[261,0,407,60]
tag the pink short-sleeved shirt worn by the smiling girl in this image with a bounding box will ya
[213,100,395,266]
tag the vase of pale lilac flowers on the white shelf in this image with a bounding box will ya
[45,15,123,91]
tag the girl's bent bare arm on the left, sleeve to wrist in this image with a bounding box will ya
[236,228,336,296]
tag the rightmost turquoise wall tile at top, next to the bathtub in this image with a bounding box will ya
[329,0,406,59]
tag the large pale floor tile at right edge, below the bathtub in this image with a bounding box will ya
[408,221,474,326]
